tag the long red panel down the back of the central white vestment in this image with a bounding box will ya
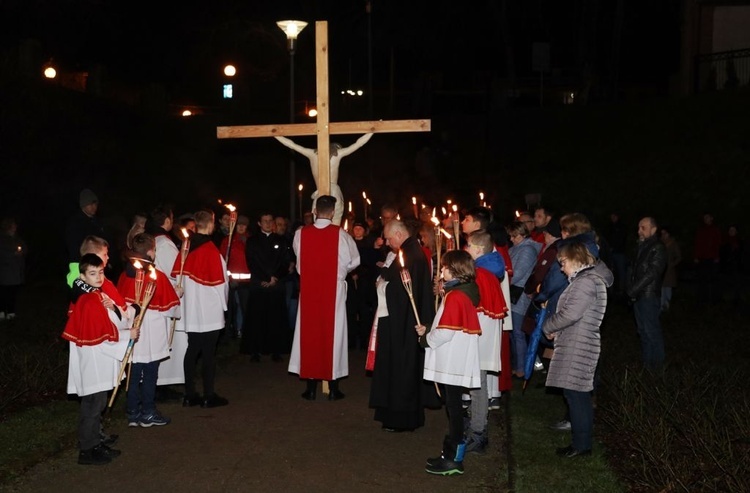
[299,224,343,380]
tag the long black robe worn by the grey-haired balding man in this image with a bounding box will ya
[370,237,439,430]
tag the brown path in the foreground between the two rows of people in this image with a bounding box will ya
[0,352,507,493]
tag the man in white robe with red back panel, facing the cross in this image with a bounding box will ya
[289,195,360,400]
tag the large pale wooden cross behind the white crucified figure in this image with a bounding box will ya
[216,21,430,195]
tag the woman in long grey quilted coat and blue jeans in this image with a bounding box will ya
[543,242,614,457]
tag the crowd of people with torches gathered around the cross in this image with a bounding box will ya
[0,185,742,475]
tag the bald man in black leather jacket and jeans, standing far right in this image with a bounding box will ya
[627,217,667,368]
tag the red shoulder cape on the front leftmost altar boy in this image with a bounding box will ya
[62,290,119,346]
